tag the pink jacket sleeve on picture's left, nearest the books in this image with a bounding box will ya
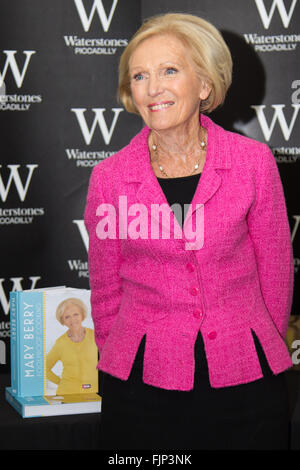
[84,164,122,353]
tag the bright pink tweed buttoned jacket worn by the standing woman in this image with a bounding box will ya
[85,115,293,390]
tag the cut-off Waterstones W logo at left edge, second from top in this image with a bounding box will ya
[0,164,44,225]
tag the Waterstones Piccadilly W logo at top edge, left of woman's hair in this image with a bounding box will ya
[64,0,128,55]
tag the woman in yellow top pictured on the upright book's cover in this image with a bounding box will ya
[46,298,98,395]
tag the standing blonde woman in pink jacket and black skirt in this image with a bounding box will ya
[85,14,293,449]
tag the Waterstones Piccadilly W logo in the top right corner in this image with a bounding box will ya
[244,0,300,52]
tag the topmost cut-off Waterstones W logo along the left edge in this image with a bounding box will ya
[0,50,42,111]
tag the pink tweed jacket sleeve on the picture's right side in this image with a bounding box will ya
[248,145,294,338]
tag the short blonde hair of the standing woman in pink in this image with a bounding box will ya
[118,13,232,114]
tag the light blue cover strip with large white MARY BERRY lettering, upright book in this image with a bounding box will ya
[18,291,44,397]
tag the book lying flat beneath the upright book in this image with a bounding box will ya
[5,387,101,418]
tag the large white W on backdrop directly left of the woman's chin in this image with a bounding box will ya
[71,108,124,145]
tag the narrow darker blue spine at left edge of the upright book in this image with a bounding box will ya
[9,292,19,394]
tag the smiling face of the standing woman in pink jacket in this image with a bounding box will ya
[129,35,210,131]
